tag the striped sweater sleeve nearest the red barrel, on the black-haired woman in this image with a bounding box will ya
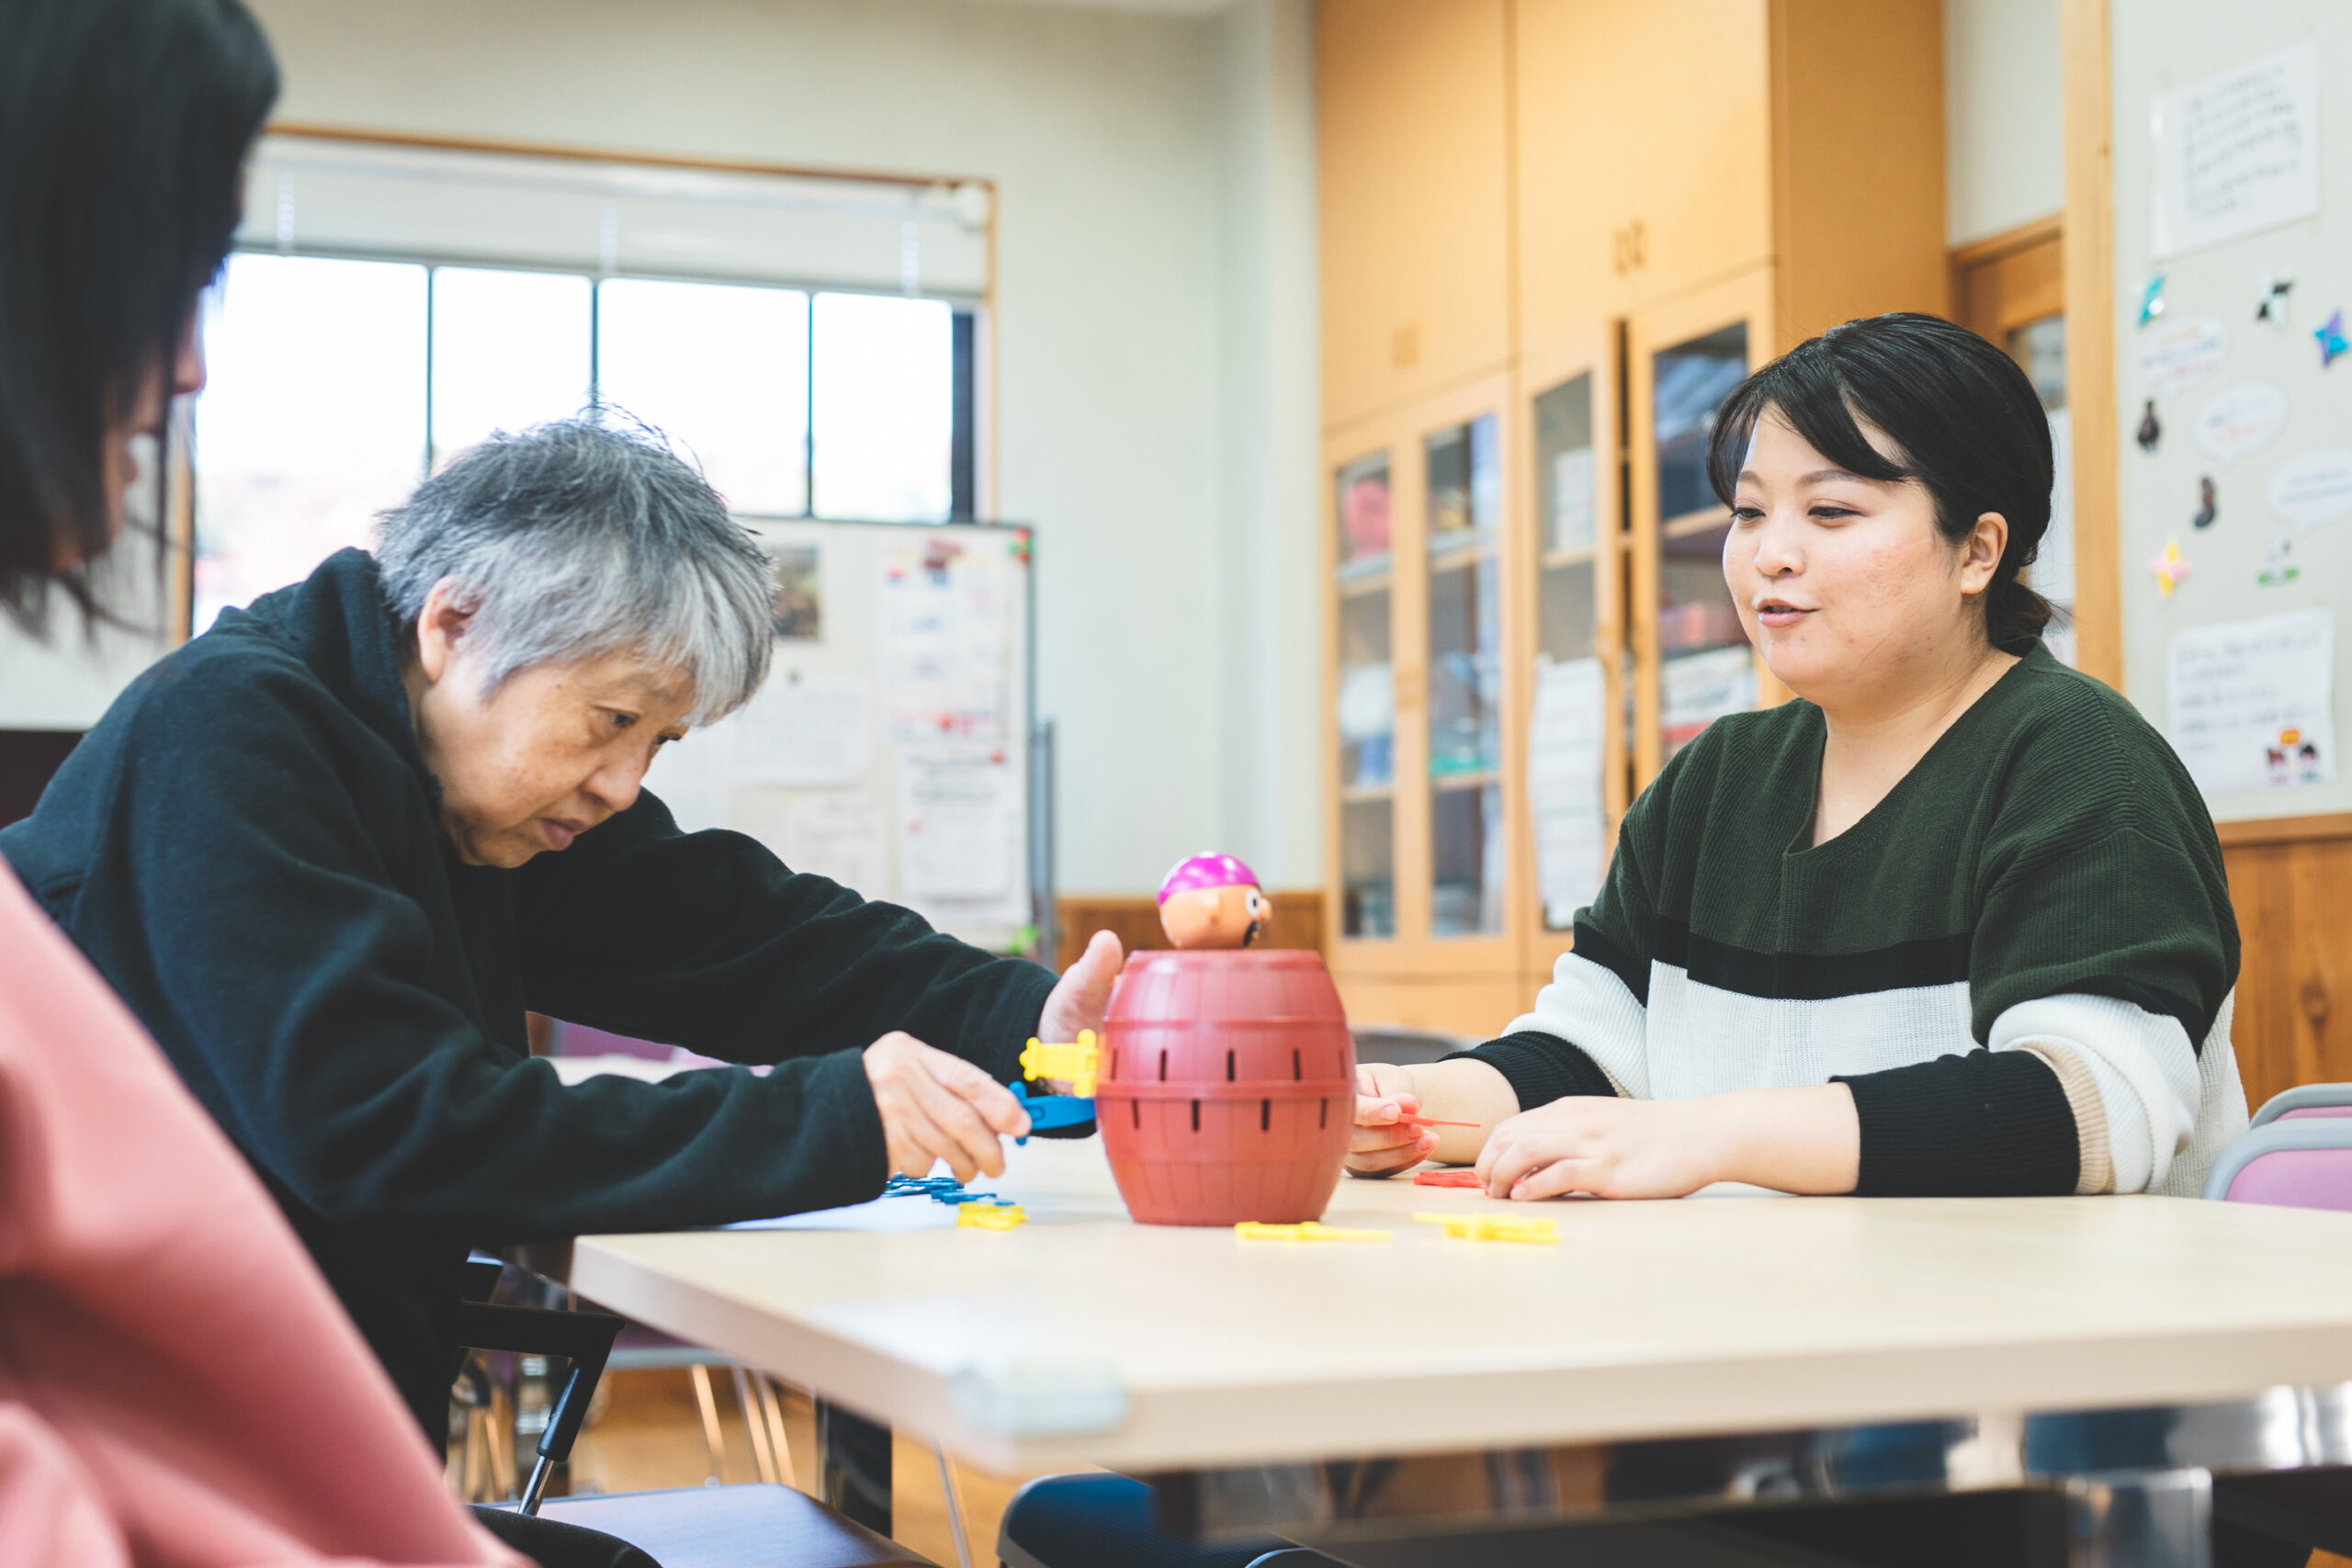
[1446,795,1663,1110]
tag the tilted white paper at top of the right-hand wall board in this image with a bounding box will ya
[2152,42,2319,256]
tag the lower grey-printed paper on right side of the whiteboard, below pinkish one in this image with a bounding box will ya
[899,748,1028,919]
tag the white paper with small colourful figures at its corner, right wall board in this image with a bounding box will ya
[2166,609,2335,795]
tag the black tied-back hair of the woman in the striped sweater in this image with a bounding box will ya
[1708,310,2058,653]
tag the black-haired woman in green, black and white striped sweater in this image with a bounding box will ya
[1348,315,2246,1199]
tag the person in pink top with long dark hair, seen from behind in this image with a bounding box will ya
[0,0,522,1568]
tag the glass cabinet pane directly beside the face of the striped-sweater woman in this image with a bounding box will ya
[1651,322,1757,764]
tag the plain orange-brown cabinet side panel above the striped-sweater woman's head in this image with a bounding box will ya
[1767,0,1950,353]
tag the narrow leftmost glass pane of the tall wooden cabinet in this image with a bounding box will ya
[1334,451,1397,938]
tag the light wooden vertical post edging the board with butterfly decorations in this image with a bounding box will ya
[2058,0,2124,691]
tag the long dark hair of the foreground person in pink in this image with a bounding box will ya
[0,0,277,626]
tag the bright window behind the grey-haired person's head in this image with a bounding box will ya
[193,252,974,630]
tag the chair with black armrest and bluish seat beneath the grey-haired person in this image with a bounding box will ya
[457,1274,936,1568]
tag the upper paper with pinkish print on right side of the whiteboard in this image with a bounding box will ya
[882,538,1012,745]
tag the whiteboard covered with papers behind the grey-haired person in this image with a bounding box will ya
[644,520,1051,952]
